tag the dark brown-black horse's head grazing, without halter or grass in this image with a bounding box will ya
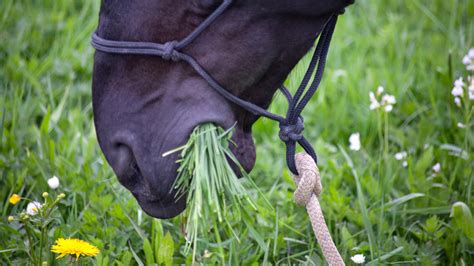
[93,0,353,218]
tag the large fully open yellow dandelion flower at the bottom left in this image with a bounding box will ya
[51,238,100,260]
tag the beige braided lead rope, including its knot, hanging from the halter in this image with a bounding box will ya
[293,153,345,266]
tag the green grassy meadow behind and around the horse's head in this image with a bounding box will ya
[0,0,474,265]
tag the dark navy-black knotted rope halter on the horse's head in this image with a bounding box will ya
[92,0,337,174]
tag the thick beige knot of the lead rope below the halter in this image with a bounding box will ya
[293,153,322,206]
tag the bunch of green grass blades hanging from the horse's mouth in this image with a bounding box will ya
[167,123,258,261]
